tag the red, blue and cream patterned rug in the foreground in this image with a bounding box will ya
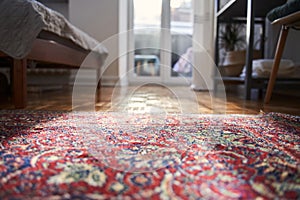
[0,111,300,199]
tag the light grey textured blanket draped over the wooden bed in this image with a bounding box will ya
[0,0,108,61]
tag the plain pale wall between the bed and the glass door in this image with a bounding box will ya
[69,0,119,83]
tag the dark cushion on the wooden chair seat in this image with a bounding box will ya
[267,0,300,21]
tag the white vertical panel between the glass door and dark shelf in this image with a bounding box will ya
[192,0,215,90]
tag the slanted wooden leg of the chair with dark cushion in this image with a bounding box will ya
[265,25,289,104]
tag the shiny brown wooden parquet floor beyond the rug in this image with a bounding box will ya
[0,85,300,115]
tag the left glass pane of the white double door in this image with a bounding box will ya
[131,0,162,82]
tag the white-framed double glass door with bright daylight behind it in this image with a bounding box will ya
[128,0,194,85]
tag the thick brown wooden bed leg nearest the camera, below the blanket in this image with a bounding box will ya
[12,59,27,109]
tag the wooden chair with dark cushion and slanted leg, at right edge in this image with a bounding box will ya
[264,0,300,104]
